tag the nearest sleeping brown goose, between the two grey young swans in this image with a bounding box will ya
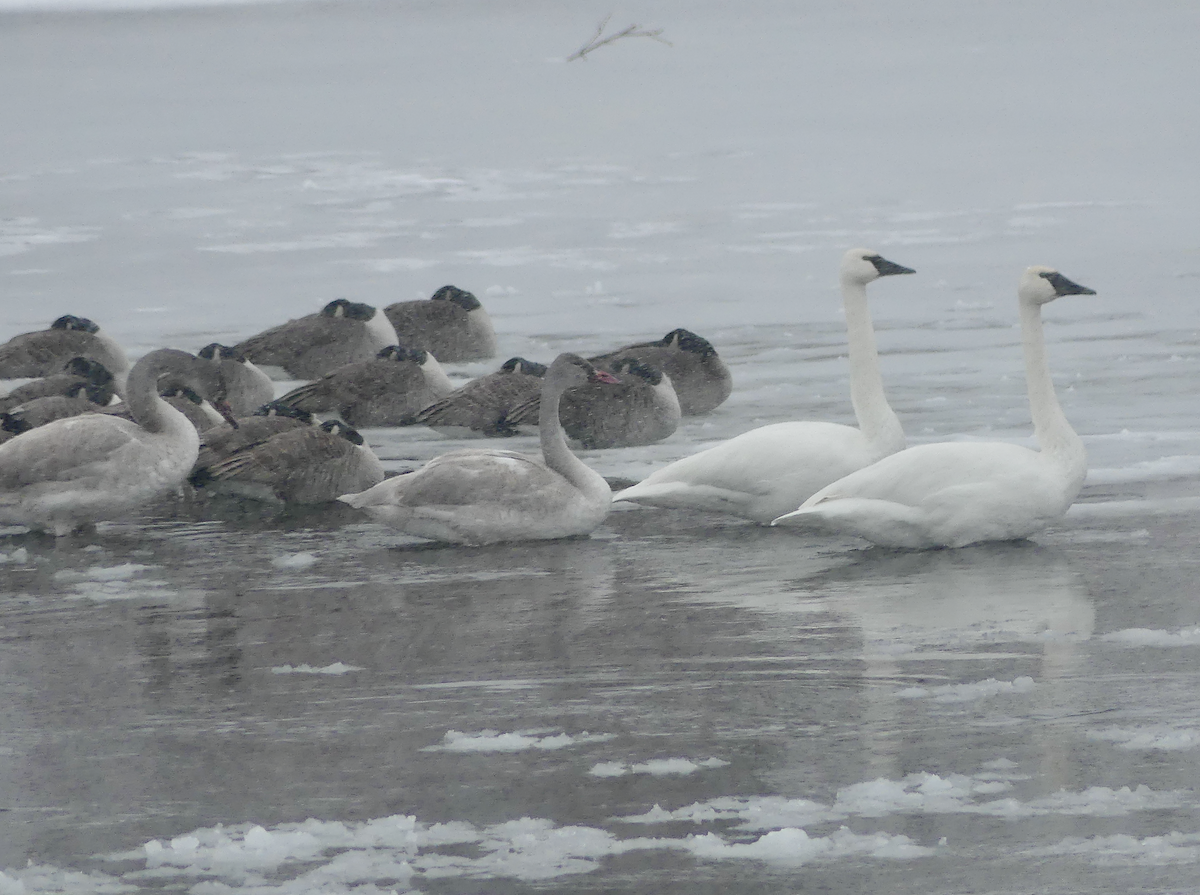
[192,420,384,504]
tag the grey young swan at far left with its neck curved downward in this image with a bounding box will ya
[0,348,232,535]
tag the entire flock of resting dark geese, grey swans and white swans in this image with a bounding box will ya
[0,248,1094,548]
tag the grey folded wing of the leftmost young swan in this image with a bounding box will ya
[0,414,142,491]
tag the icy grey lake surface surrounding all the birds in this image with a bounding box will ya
[0,0,1200,895]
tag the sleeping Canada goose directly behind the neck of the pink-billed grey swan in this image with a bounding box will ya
[510,358,679,450]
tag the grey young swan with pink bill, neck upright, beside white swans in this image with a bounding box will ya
[338,354,617,545]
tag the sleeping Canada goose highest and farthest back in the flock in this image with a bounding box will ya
[384,286,496,364]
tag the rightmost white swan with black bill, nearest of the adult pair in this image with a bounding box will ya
[773,268,1096,548]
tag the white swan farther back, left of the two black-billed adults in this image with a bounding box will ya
[613,248,913,523]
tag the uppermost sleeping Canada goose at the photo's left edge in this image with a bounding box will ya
[0,314,130,394]
